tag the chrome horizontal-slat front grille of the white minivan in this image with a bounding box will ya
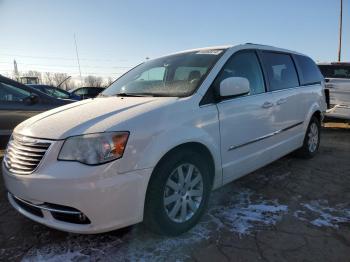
[4,134,51,175]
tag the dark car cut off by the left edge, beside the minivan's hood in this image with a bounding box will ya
[0,75,74,147]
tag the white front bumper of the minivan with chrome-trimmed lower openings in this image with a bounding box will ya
[2,161,152,234]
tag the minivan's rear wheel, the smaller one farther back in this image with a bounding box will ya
[296,116,321,159]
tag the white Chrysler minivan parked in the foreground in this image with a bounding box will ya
[2,44,326,235]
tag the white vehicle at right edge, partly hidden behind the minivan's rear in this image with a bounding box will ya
[318,62,350,121]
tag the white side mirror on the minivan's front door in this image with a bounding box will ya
[220,77,250,97]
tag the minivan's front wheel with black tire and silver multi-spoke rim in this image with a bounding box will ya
[144,150,212,236]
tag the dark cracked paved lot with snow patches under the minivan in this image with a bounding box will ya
[0,124,350,261]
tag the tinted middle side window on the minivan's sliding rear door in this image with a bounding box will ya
[262,52,299,91]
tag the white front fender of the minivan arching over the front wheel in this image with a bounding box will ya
[118,105,222,188]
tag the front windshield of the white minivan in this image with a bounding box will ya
[102,49,224,97]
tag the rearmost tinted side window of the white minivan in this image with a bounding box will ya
[295,55,323,85]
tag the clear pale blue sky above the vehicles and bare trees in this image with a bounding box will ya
[0,0,350,82]
